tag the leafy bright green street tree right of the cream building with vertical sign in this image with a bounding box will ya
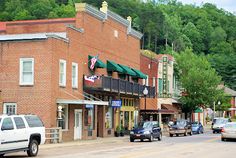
[175,49,223,118]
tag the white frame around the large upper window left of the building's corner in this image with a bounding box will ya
[19,58,34,85]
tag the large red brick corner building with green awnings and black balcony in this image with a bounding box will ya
[0,3,155,141]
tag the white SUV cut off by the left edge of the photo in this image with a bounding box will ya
[0,115,45,157]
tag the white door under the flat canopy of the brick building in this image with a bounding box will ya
[74,109,82,140]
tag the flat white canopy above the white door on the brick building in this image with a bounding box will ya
[57,99,108,105]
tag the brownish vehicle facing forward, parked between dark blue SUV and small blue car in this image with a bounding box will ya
[169,120,192,137]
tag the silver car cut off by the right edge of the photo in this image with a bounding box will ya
[221,122,236,141]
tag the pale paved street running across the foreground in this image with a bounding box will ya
[6,131,236,158]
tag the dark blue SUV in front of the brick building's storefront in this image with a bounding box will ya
[130,121,162,142]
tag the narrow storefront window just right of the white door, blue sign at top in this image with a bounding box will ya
[84,105,94,130]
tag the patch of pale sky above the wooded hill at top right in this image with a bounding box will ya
[178,0,236,13]
